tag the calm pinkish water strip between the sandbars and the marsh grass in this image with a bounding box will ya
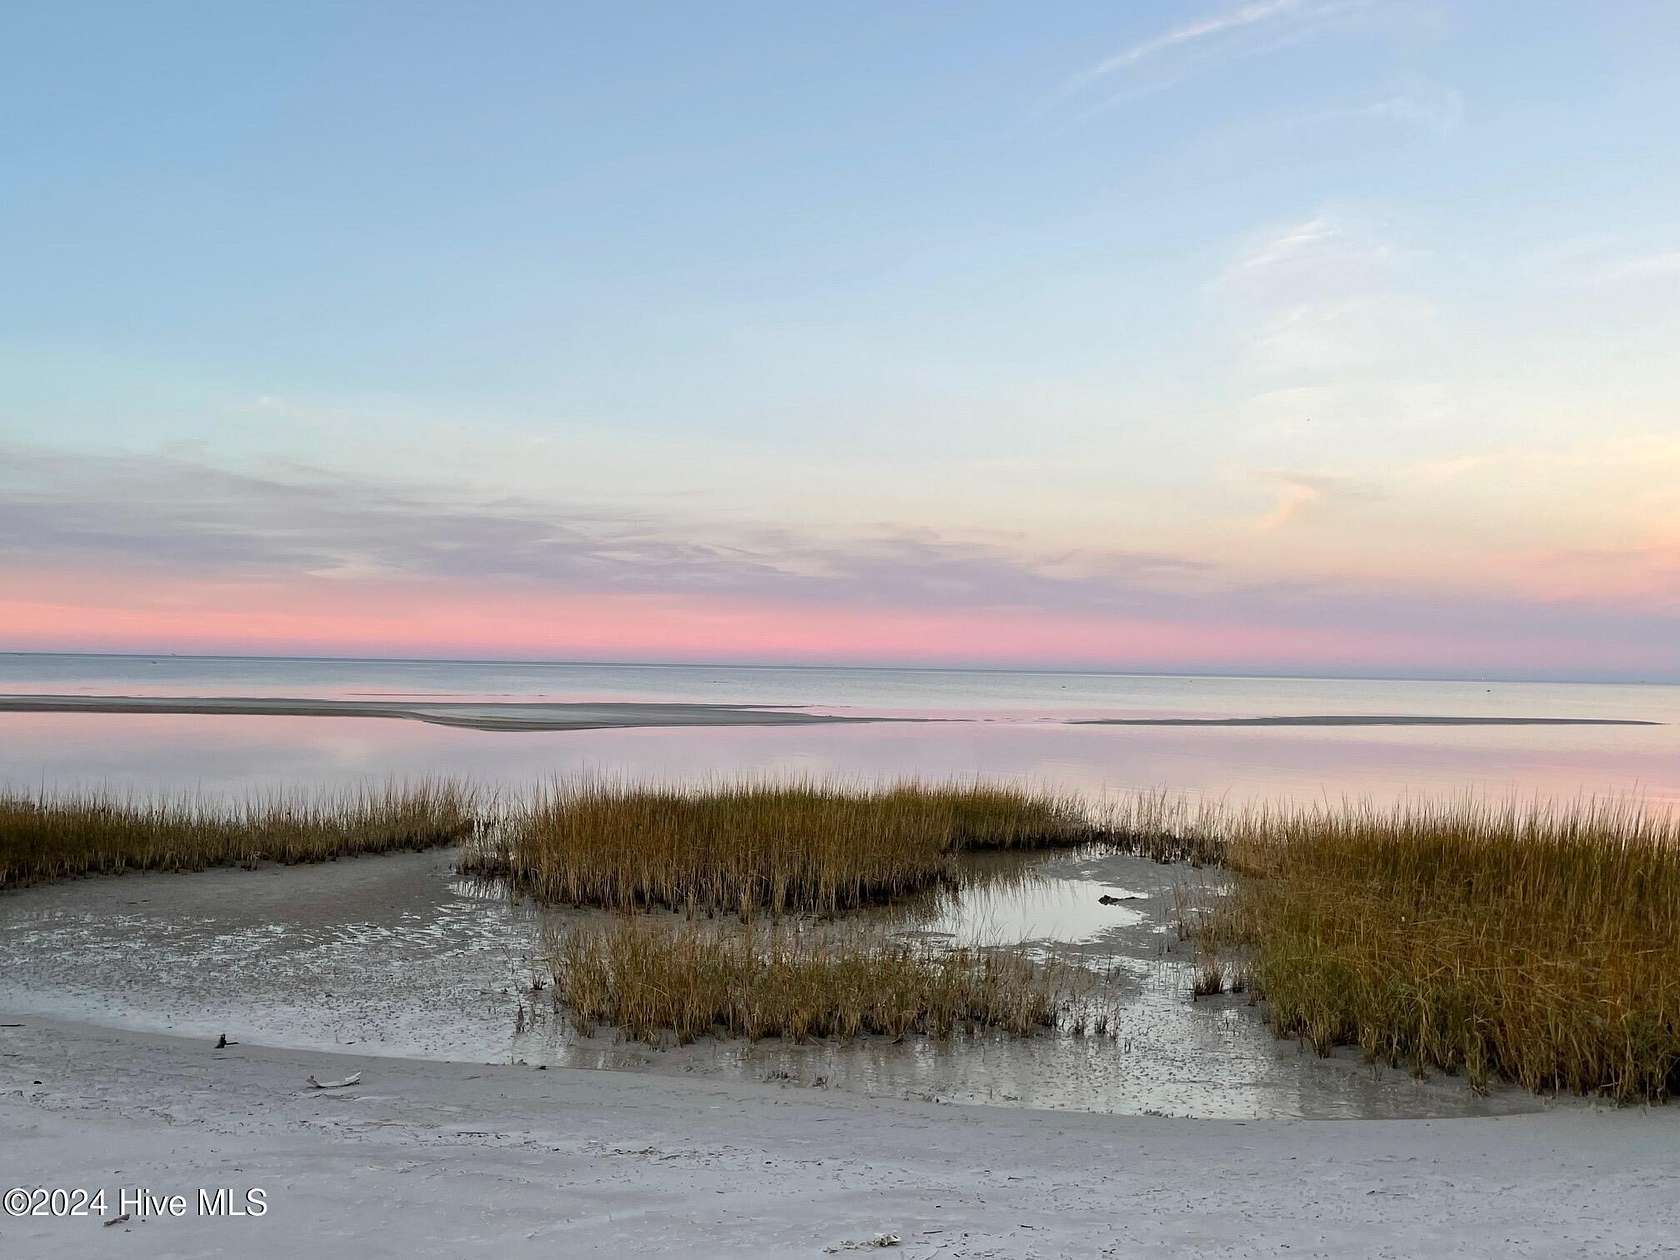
[0,712,1680,803]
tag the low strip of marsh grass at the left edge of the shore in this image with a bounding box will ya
[0,780,480,889]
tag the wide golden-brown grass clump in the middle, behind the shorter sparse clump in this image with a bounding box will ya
[464,781,1097,917]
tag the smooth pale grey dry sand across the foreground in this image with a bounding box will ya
[0,1016,1680,1260]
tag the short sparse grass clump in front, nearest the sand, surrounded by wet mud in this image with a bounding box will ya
[549,917,1057,1045]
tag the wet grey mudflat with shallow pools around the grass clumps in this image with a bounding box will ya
[0,850,1539,1117]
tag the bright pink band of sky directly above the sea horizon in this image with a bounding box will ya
[0,571,1667,675]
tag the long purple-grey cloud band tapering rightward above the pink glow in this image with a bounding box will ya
[0,447,1215,608]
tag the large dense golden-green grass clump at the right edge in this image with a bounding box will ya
[1228,801,1680,1100]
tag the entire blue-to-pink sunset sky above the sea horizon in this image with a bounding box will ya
[0,0,1680,680]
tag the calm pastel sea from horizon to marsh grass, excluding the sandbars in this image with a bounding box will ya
[0,654,1680,805]
